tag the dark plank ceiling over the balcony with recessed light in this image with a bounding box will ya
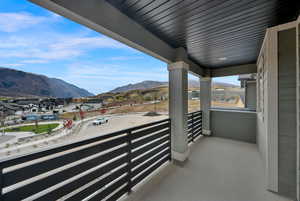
[106,0,300,68]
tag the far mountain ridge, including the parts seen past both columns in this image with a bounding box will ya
[109,80,237,93]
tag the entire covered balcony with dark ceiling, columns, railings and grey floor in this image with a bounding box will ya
[0,0,300,201]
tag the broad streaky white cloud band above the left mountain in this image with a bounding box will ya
[0,33,129,60]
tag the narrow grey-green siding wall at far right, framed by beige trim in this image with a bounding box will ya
[278,28,297,198]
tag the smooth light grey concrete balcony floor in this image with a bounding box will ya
[129,137,290,201]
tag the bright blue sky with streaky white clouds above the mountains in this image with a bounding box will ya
[0,0,236,93]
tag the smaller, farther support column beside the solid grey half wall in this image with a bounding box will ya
[200,77,211,135]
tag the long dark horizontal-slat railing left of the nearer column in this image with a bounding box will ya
[0,119,171,201]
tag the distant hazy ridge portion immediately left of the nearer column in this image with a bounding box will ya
[110,80,168,93]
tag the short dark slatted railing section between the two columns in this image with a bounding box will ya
[188,111,202,143]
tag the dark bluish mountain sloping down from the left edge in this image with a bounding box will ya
[0,67,93,98]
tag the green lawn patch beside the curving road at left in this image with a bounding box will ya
[4,123,59,134]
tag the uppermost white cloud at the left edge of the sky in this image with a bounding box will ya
[0,13,47,32]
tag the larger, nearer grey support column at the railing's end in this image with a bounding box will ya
[168,61,189,162]
